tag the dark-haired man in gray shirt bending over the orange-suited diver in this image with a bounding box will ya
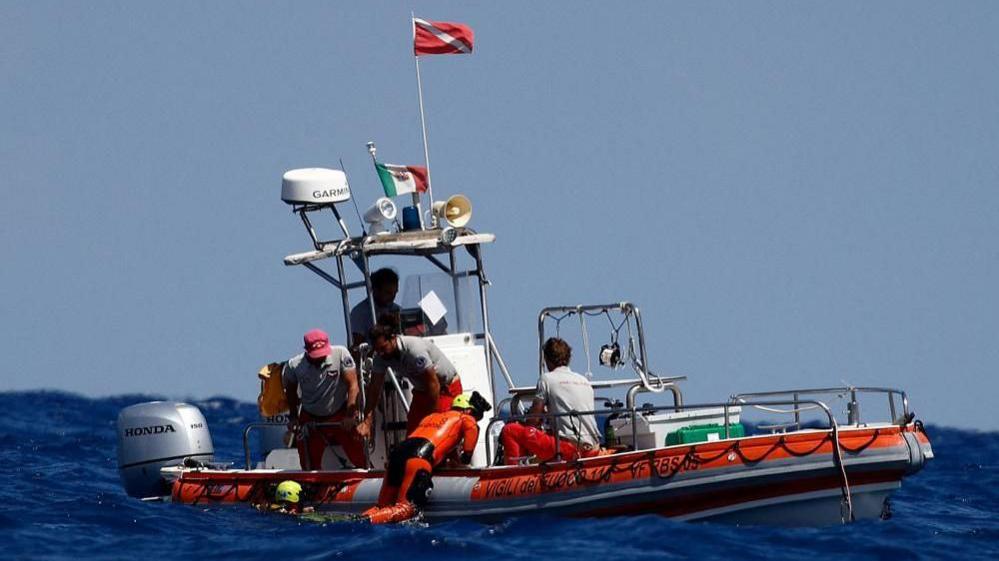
[361,324,462,435]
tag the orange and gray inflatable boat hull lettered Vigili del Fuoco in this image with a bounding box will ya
[172,425,932,526]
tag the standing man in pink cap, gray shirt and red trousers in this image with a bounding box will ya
[282,329,367,470]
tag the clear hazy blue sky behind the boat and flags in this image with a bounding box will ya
[0,0,999,430]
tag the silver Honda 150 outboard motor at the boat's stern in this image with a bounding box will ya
[118,401,215,498]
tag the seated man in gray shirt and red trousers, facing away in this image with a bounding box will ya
[500,337,600,464]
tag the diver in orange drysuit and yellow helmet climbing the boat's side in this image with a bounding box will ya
[361,392,492,524]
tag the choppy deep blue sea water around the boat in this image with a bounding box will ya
[0,392,999,561]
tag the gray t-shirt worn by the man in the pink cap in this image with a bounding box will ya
[281,345,354,417]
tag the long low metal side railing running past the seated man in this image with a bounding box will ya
[486,398,840,465]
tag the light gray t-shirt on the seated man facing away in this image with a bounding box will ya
[536,366,600,447]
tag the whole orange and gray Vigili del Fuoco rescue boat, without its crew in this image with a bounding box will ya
[118,170,933,525]
